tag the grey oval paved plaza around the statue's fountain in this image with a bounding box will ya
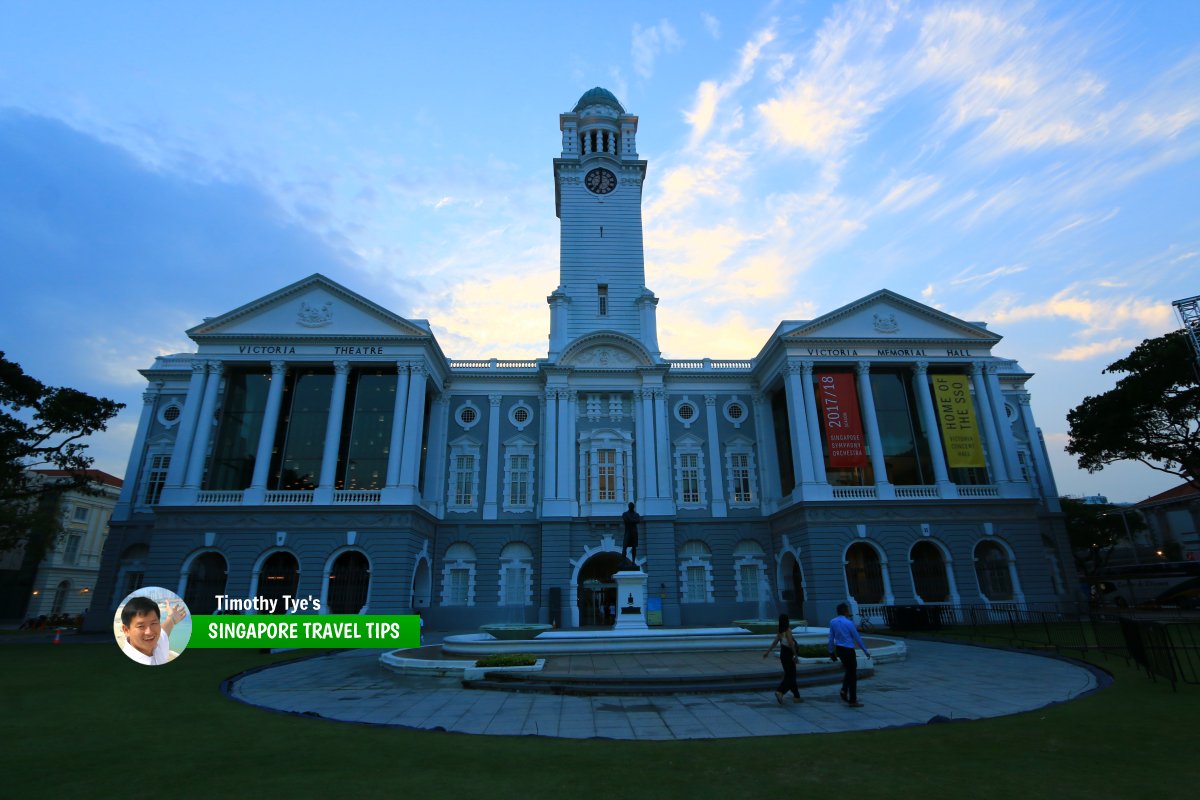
[228,639,1102,740]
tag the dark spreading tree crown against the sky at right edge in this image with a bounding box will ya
[1067,331,1200,489]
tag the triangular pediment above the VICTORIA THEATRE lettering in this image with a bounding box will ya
[187,275,431,339]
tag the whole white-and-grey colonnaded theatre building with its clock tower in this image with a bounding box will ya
[94,89,1074,628]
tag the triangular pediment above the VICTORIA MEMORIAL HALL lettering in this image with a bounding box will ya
[782,289,1001,345]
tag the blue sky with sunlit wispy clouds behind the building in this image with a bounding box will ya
[0,0,1200,500]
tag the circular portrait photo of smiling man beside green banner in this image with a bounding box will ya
[113,587,192,666]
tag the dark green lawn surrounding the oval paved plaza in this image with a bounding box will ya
[0,643,1200,800]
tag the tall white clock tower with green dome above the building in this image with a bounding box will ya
[546,86,660,362]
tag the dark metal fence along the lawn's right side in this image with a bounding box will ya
[882,603,1200,688]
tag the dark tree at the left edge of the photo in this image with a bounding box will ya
[0,351,125,554]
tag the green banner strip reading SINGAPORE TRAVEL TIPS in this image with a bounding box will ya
[187,614,421,649]
